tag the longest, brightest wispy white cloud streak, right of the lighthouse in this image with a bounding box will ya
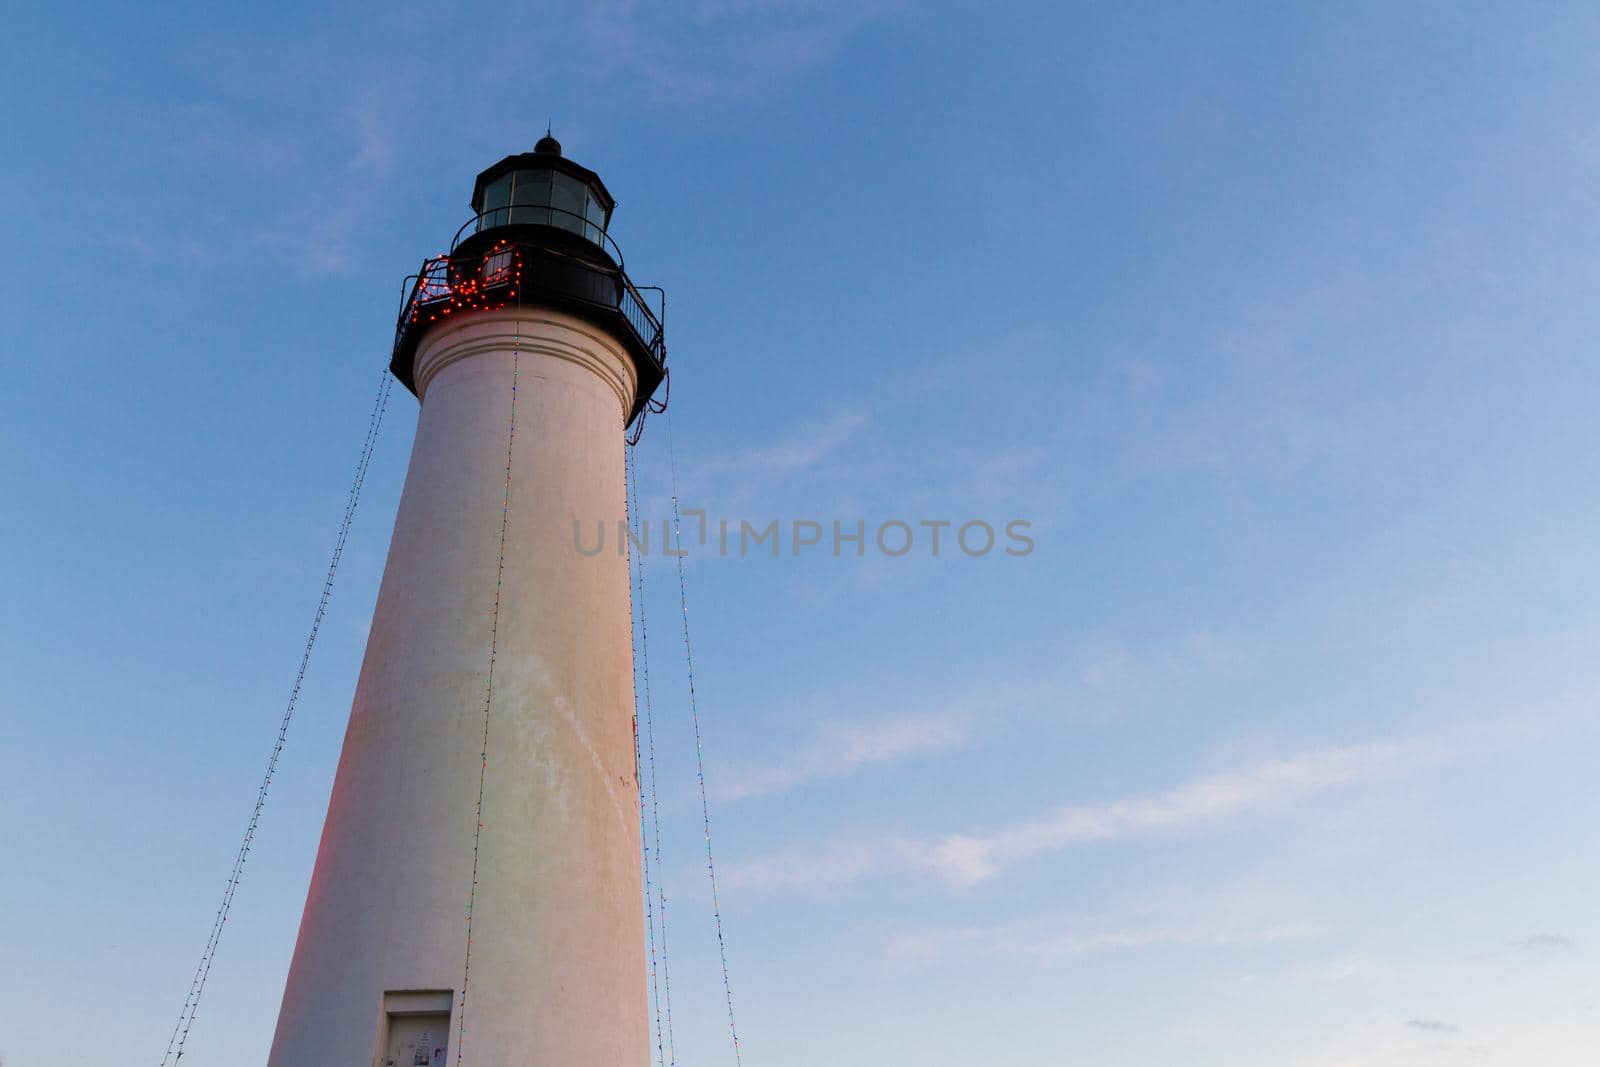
[728,742,1446,889]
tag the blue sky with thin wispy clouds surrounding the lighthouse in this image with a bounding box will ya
[0,0,1600,1067]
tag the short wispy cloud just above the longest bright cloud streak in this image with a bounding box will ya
[718,712,976,800]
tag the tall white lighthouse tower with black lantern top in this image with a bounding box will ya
[267,136,666,1067]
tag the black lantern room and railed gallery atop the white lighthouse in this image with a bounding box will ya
[389,133,666,422]
